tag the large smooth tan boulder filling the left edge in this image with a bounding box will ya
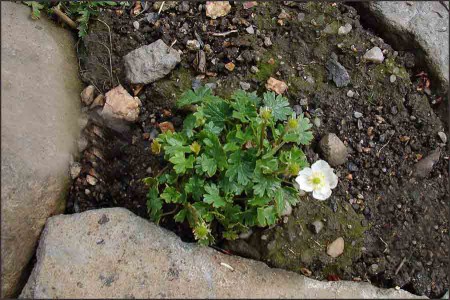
[1,2,82,298]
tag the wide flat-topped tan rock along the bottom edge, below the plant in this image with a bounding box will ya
[20,208,426,299]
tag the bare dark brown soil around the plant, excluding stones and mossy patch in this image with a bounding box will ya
[67,1,449,297]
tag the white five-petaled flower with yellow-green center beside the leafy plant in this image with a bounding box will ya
[295,160,338,200]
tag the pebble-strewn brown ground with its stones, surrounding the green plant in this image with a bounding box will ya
[67,1,449,297]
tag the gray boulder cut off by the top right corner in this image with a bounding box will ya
[357,1,449,91]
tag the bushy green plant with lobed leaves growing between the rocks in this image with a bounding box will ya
[145,87,314,244]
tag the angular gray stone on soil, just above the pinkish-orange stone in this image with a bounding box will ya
[123,40,181,84]
